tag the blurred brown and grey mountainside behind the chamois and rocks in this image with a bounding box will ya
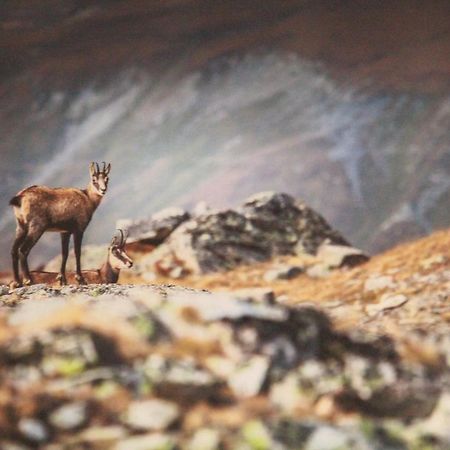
[0,0,450,264]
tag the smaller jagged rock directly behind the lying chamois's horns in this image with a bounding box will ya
[116,208,190,245]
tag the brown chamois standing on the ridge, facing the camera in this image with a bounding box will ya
[9,163,111,286]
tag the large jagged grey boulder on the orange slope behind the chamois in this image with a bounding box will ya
[137,192,354,276]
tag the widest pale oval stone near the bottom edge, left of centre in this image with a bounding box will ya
[125,399,179,430]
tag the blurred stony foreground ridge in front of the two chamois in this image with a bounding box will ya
[0,285,450,450]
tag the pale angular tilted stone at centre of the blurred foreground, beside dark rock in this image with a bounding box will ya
[228,356,269,397]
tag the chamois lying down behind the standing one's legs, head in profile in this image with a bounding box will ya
[31,230,133,284]
